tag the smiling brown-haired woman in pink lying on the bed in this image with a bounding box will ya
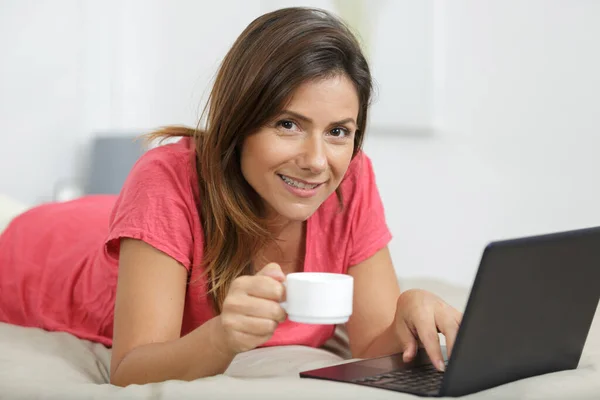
[0,8,461,386]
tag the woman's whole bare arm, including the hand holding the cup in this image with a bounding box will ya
[110,239,285,386]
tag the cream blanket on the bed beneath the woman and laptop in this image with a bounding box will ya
[0,197,600,400]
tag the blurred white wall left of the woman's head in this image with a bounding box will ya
[0,0,261,200]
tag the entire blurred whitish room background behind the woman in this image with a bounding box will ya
[0,0,600,285]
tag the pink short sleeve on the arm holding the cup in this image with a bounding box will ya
[105,145,194,271]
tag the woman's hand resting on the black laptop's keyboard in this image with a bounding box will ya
[394,289,462,371]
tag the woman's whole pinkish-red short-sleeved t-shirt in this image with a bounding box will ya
[0,138,391,347]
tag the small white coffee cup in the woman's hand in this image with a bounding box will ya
[281,272,354,325]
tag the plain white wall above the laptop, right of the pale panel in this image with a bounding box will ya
[368,0,600,283]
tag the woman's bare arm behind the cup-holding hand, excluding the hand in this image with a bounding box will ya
[110,239,234,386]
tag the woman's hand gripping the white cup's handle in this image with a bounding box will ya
[213,263,287,355]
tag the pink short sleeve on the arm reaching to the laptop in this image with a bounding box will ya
[349,152,392,266]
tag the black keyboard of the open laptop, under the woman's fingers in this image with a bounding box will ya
[352,364,444,393]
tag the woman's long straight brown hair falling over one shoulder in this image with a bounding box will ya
[150,7,372,312]
